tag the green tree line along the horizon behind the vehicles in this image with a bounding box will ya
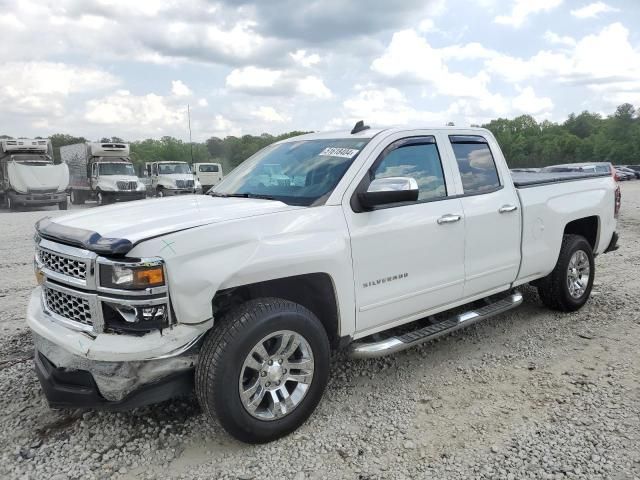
[0,103,640,173]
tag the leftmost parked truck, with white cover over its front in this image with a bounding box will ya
[0,138,69,210]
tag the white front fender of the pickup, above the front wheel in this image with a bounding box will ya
[129,206,355,336]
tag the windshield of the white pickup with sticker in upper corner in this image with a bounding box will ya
[211,139,369,206]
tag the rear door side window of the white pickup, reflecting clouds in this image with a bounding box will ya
[449,135,500,195]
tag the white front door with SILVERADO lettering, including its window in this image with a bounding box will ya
[343,134,465,334]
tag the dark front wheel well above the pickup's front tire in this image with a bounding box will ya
[211,272,340,348]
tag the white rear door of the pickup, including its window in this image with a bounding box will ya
[449,135,521,297]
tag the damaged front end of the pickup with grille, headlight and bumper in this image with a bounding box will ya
[27,229,206,410]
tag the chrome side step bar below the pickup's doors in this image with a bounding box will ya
[349,291,522,359]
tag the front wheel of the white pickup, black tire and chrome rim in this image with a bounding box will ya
[195,298,330,443]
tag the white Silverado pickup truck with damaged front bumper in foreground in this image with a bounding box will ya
[27,122,620,442]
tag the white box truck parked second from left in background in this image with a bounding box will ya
[60,142,146,205]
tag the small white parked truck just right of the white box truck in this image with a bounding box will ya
[145,161,202,197]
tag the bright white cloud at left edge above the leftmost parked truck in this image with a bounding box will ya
[0,62,119,116]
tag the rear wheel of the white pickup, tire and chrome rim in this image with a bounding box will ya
[537,235,595,312]
